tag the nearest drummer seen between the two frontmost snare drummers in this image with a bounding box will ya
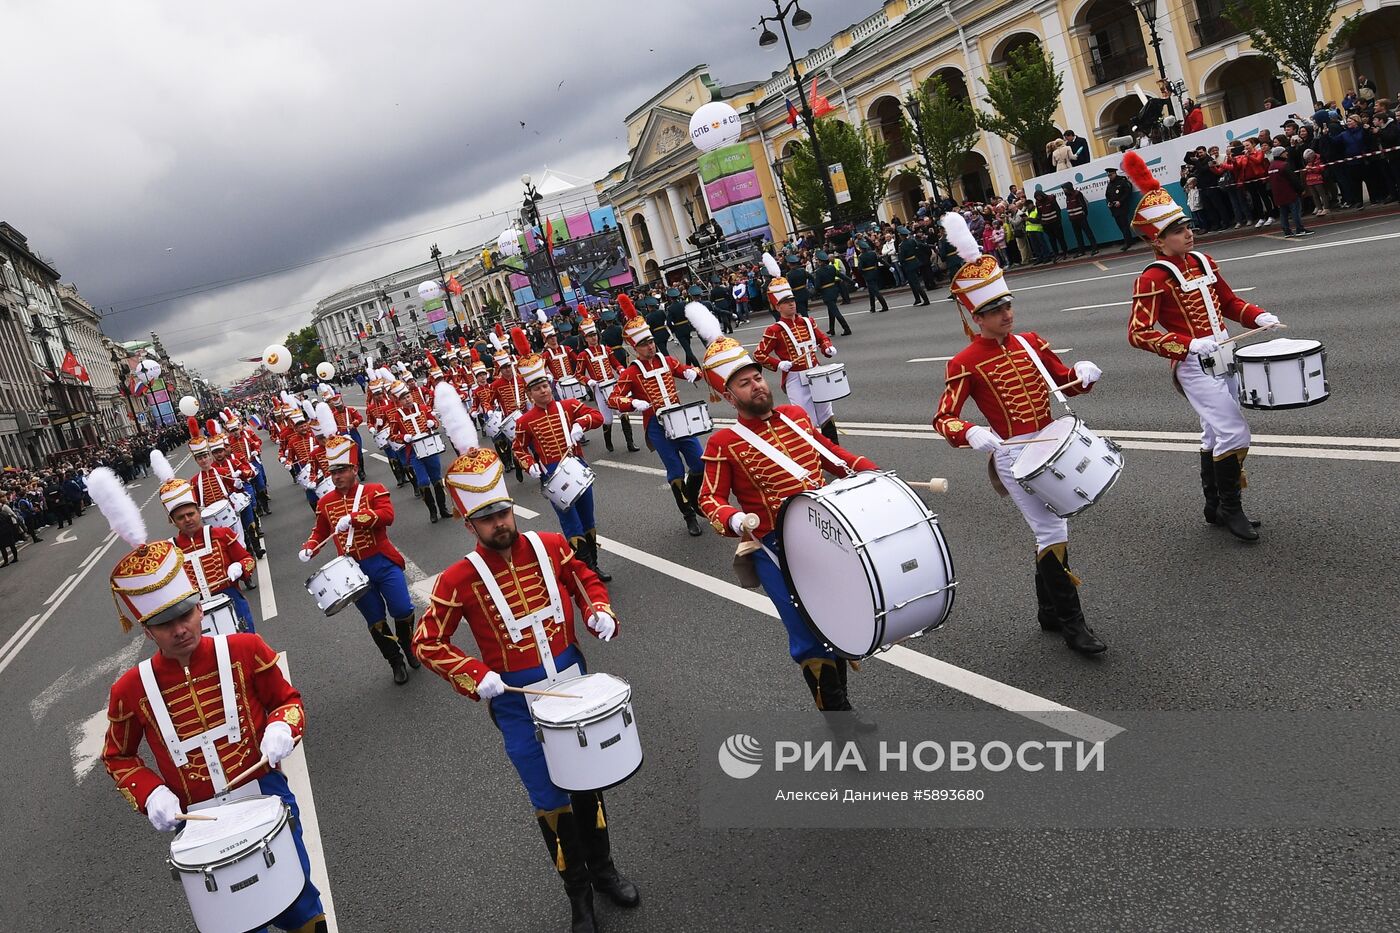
[298,436,419,685]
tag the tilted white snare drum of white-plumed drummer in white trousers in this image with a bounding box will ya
[1011,415,1123,518]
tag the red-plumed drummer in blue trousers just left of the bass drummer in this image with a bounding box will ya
[608,294,704,538]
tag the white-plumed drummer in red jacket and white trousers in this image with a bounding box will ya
[934,213,1107,654]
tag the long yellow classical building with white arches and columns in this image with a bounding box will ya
[596,0,1400,273]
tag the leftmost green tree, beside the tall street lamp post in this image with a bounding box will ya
[783,118,889,227]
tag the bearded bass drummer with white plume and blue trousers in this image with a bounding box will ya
[686,305,878,712]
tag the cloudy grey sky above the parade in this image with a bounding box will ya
[0,0,851,381]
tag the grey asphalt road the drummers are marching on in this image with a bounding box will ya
[0,210,1400,932]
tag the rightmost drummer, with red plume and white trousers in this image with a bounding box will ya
[1123,151,1278,541]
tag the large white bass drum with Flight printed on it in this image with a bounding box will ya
[777,472,958,658]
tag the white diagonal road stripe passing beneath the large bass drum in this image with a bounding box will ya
[598,535,1123,741]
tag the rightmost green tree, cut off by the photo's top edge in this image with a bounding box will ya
[1225,0,1361,104]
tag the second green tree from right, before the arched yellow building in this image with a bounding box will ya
[977,42,1064,175]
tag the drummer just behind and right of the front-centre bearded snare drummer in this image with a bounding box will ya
[511,348,612,583]
